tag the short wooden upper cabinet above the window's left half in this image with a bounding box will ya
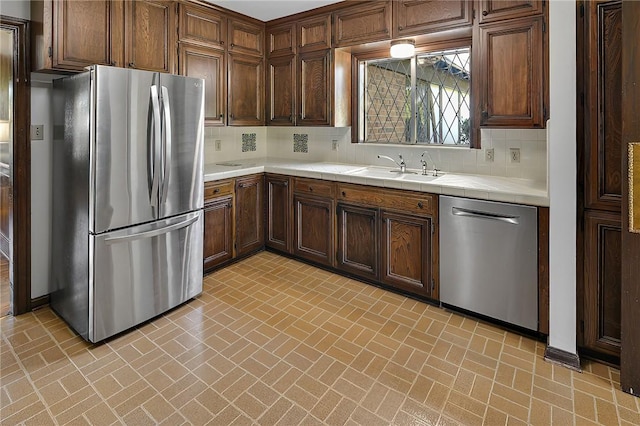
[333,1,392,47]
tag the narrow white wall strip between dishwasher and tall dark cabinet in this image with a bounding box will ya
[548,0,577,354]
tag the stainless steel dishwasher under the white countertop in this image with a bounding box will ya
[440,196,538,331]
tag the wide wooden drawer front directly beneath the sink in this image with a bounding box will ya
[338,184,436,215]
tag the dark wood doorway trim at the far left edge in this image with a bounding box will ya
[0,15,31,315]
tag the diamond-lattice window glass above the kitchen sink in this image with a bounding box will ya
[359,48,471,146]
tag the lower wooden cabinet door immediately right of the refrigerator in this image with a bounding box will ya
[203,196,233,271]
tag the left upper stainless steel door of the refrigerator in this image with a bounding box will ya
[89,66,161,233]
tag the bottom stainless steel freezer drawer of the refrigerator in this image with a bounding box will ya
[89,210,203,342]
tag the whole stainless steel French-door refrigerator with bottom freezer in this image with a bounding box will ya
[51,66,204,342]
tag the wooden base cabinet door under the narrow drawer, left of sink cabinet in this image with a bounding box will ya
[293,194,335,266]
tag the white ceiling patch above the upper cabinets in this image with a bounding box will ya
[207,0,341,21]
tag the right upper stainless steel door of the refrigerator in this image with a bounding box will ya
[160,74,204,217]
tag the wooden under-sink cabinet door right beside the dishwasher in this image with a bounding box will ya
[380,210,435,297]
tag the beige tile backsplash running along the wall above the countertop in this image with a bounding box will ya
[205,126,547,181]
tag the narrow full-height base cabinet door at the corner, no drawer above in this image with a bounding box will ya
[265,175,292,253]
